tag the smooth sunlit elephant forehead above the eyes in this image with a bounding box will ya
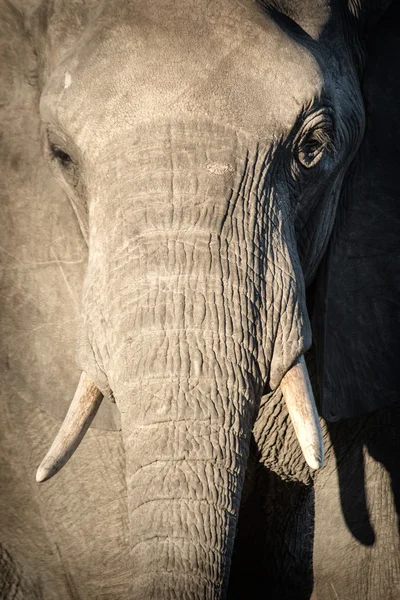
[43,2,323,144]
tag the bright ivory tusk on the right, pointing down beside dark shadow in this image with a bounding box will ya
[281,356,324,469]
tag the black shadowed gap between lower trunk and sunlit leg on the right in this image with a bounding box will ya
[228,439,314,600]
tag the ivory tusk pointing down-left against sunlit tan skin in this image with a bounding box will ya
[36,372,103,483]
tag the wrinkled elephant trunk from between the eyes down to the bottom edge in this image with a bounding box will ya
[36,124,318,600]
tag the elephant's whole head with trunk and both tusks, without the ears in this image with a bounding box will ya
[32,0,394,599]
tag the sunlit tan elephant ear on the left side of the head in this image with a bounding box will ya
[0,2,120,429]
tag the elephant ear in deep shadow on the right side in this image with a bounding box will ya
[313,4,400,421]
